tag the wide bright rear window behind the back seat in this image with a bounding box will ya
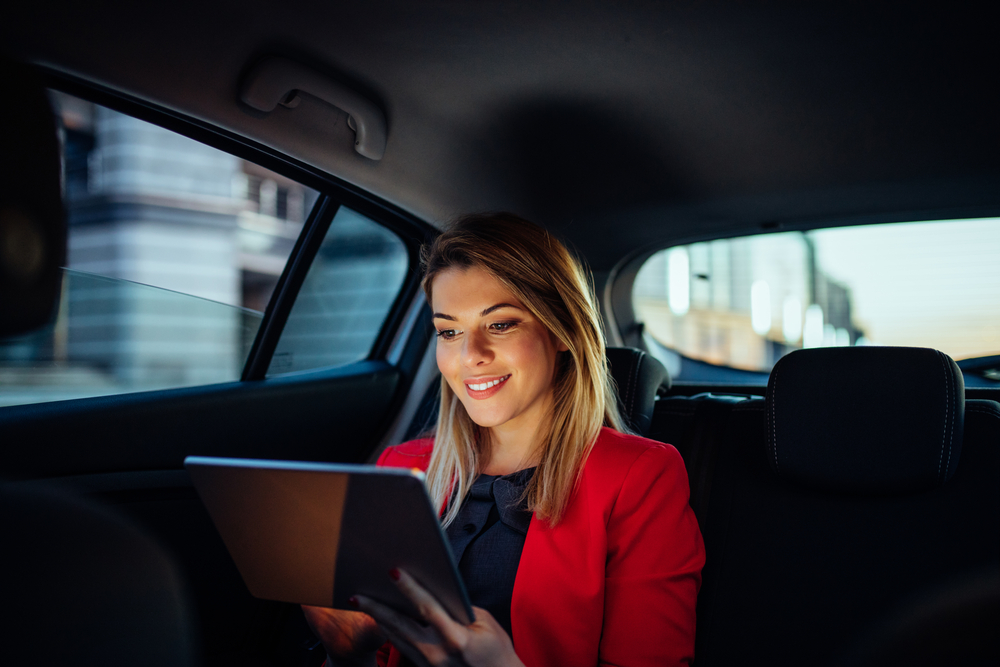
[633,219,1000,380]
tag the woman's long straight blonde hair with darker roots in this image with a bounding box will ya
[421,213,625,526]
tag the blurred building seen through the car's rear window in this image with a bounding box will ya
[633,233,861,371]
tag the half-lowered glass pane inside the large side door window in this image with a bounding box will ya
[0,270,262,405]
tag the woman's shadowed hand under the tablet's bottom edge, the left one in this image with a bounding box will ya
[302,605,385,667]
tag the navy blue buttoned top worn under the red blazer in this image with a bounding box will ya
[445,468,535,635]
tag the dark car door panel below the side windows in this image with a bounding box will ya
[0,361,403,665]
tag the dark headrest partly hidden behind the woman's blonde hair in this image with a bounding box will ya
[607,347,670,435]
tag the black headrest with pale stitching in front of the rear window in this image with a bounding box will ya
[766,347,965,494]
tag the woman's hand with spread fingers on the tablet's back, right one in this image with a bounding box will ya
[355,570,524,667]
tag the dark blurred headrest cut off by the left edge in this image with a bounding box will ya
[0,56,66,336]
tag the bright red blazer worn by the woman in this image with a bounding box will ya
[378,428,705,667]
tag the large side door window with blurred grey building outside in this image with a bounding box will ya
[0,92,318,406]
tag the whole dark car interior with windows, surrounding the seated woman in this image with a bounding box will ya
[0,0,1000,667]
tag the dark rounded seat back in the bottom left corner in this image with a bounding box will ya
[0,484,196,667]
